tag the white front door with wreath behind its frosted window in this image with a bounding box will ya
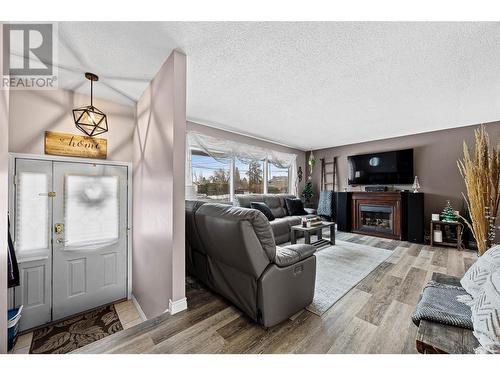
[52,162,127,320]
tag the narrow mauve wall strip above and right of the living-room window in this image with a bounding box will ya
[186,121,306,195]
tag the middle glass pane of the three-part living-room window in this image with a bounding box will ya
[234,160,264,194]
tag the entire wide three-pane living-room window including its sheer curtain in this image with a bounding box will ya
[186,131,297,202]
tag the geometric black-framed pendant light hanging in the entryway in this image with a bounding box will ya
[73,72,108,137]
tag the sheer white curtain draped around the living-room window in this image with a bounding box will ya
[186,132,297,199]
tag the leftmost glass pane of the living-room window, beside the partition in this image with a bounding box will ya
[191,150,232,201]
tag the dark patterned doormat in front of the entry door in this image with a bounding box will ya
[30,305,123,354]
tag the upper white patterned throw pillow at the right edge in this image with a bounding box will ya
[460,245,500,298]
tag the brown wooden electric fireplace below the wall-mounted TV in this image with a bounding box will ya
[352,192,402,239]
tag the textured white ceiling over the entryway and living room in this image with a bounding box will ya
[45,22,500,149]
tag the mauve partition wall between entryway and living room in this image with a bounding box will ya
[132,51,186,318]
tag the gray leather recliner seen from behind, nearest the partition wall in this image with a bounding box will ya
[186,201,316,327]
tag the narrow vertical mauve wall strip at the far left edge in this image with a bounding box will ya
[0,22,9,354]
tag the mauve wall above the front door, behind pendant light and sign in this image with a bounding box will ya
[9,90,135,161]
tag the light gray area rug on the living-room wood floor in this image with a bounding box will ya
[306,240,392,316]
